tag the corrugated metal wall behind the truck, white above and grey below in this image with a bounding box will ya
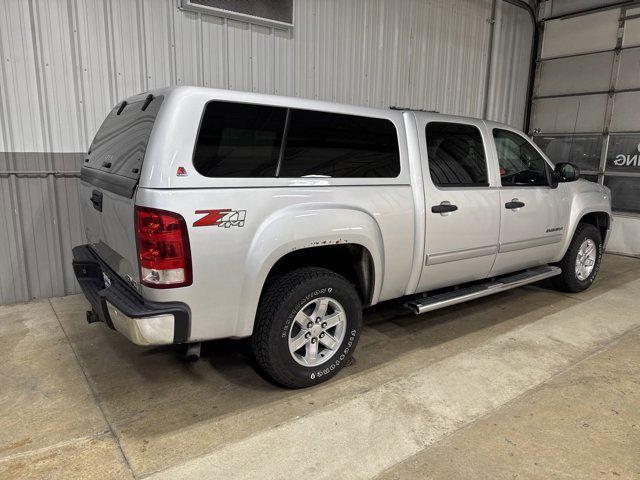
[0,0,532,304]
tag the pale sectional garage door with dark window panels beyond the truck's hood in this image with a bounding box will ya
[531,1,640,214]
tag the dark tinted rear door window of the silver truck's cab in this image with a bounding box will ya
[426,122,489,187]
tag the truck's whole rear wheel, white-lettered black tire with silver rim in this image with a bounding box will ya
[251,267,362,388]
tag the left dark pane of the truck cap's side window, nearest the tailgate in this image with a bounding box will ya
[193,102,287,177]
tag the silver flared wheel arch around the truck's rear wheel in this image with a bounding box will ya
[235,204,384,337]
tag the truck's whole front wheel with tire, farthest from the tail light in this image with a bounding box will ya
[552,223,603,293]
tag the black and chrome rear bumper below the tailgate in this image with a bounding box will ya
[73,245,191,345]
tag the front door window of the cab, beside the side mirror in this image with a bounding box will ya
[493,129,549,187]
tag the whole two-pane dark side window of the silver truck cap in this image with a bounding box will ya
[193,101,400,178]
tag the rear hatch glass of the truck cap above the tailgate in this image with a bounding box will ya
[83,96,164,180]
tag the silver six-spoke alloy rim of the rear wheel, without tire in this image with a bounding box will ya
[289,297,347,367]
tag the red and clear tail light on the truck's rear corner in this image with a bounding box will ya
[135,207,192,288]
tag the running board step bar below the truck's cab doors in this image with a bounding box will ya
[404,266,562,315]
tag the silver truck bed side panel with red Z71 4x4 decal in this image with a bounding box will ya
[136,185,414,341]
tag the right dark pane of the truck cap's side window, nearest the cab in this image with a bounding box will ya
[279,110,400,178]
